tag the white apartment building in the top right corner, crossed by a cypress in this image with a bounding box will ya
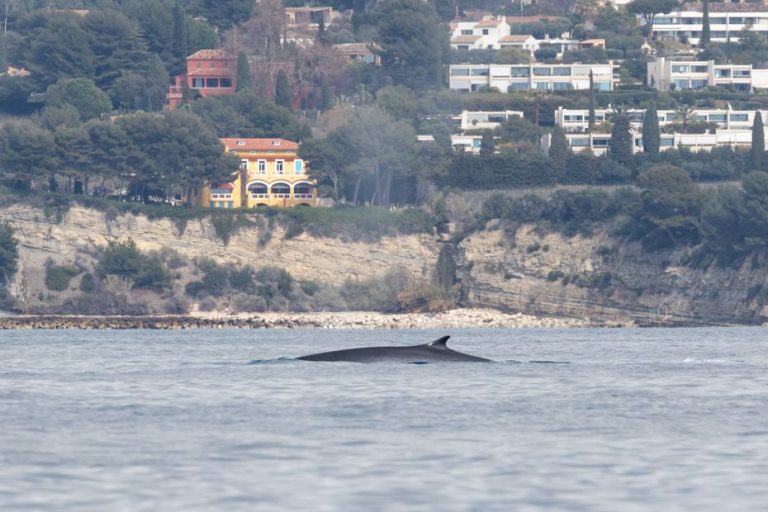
[651,6,768,45]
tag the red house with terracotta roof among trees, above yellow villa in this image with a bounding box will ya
[168,50,237,110]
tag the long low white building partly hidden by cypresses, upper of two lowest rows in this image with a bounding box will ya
[555,107,768,133]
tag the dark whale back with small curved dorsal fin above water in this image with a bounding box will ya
[296,336,490,363]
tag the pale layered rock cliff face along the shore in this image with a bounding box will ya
[0,206,768,324]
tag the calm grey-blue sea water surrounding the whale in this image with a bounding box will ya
[0,328,768,512]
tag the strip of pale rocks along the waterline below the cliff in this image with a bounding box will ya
[0,309,616,329]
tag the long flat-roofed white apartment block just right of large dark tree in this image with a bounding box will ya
[448,61,619,92]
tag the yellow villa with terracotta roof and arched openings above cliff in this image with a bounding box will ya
[198,138,318,208]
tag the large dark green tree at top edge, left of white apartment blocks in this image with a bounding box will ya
[371,0,449,90]
